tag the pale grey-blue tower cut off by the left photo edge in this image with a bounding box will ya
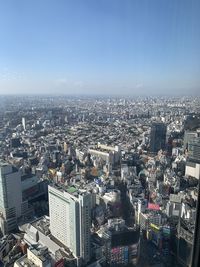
[0,161,22,234]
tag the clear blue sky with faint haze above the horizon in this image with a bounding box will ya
[0,0,200,95]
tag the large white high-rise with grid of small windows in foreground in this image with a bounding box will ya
[48,185,92,264]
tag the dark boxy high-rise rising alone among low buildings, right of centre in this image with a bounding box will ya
[150,122,167,153]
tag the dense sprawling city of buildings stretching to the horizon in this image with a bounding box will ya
[0,96,200,267]
